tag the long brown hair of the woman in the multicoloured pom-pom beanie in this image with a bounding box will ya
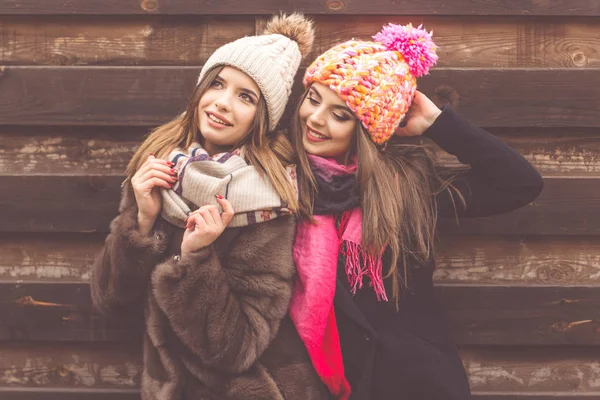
[290,90,464,306]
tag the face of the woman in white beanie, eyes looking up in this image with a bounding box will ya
[197,66,261,154]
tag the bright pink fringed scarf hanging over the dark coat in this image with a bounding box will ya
[290,156,387,400]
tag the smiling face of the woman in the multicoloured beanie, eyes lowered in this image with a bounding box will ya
[299,82,357,162]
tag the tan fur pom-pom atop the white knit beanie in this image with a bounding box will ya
[263,13,315,58]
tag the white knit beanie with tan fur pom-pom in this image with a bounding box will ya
[198,13,314,130]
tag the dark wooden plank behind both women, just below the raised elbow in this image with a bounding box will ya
[0,175,600,235]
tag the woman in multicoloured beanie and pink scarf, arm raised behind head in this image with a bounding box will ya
[290,24,542,400]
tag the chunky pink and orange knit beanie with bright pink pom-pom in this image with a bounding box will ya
[303,24,438,144]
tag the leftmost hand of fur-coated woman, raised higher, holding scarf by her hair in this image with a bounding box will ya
[131,154,177,235]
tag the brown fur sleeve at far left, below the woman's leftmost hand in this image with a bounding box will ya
[90,185,168,315]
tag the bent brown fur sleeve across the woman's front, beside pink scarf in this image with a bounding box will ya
[152,217,295,373]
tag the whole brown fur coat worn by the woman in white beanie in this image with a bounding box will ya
[91,187,329,400]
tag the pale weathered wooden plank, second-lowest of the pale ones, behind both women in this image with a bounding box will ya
[0,233,600,287]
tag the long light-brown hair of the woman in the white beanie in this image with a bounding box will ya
[126,66,298,211]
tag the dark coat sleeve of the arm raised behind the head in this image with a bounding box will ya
[424,107,543,217]
